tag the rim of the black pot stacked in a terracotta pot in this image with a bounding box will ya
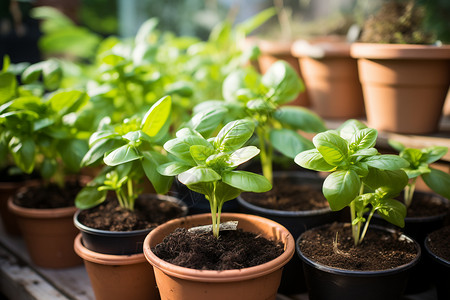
[73,193,188,237]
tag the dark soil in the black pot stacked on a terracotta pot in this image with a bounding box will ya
[78,195,183,231]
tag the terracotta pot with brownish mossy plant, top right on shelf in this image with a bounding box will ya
[351,1,450,134]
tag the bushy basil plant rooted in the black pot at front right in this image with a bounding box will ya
[295,120,409,245]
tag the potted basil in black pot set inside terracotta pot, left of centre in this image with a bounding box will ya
[73,96,187,299]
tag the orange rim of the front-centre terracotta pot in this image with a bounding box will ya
[144,213,295,282]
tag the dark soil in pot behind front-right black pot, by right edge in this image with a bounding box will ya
[399,193,450,218]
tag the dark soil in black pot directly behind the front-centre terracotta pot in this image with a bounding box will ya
[242,180,328,211]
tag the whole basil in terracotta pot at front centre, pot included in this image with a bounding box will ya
[144,120,293,299]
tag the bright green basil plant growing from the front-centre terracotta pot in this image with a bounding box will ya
[158,120,272,237]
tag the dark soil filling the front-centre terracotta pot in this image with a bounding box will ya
[152,228,283,270]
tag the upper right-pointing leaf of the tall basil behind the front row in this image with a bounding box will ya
[273,106,327,132]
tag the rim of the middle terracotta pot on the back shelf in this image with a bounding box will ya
[291,40,352,59]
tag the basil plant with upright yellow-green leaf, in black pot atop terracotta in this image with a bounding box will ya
[75,96,173,210]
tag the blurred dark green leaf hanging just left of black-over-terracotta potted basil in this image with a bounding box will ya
[58,139,89,172]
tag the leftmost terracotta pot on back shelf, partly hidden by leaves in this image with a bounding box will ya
[252,38,310,107]
